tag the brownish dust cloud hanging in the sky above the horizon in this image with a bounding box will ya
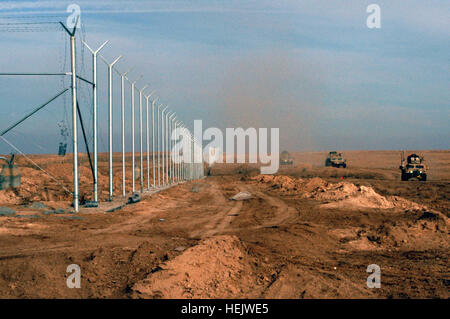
[219,51,323,150]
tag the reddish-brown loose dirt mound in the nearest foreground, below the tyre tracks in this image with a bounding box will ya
[133,236,256,298]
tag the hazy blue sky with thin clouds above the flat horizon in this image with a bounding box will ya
[0,0,450,153]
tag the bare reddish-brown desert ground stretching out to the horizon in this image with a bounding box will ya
[0,150,450,299]
